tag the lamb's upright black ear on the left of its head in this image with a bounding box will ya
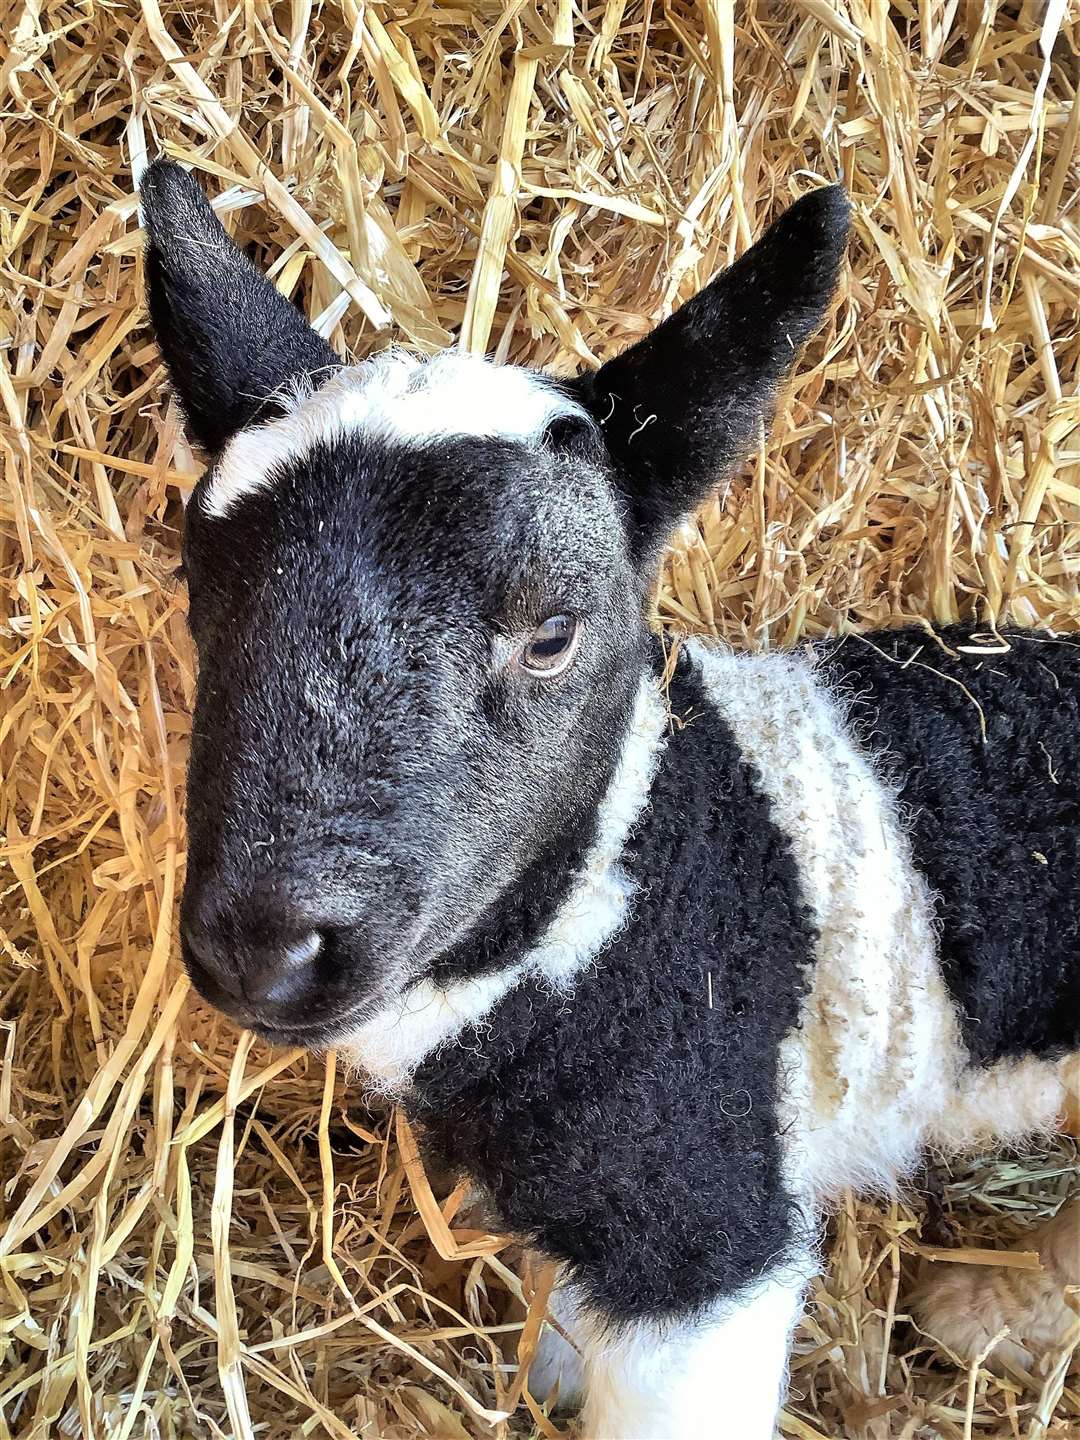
[138,160,341,454]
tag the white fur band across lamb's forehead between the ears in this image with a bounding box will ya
[202,350,586,517]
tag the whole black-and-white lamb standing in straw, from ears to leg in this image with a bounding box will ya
[141,161,1080,1440]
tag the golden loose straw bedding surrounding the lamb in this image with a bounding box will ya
[0,0,1080,1440]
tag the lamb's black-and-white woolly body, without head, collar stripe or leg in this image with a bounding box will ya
[403,631,1080,1319]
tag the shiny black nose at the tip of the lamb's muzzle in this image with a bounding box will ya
[183,924,323,1020]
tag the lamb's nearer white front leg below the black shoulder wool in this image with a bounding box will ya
[579,1263,812,1440]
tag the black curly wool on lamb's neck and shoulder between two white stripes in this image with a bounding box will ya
[406,653,815,1319]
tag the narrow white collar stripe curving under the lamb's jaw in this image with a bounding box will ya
[340,678,668,1092]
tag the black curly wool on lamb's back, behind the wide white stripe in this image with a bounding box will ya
[819,626,1080,1066]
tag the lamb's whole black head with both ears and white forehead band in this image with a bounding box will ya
[141,163,847,1043]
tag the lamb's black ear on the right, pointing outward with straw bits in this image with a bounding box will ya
[570,186,850,552]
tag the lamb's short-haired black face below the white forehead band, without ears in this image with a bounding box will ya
[181,425,645,1043]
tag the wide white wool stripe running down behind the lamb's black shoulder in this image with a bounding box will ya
[691,644,963,1201]
